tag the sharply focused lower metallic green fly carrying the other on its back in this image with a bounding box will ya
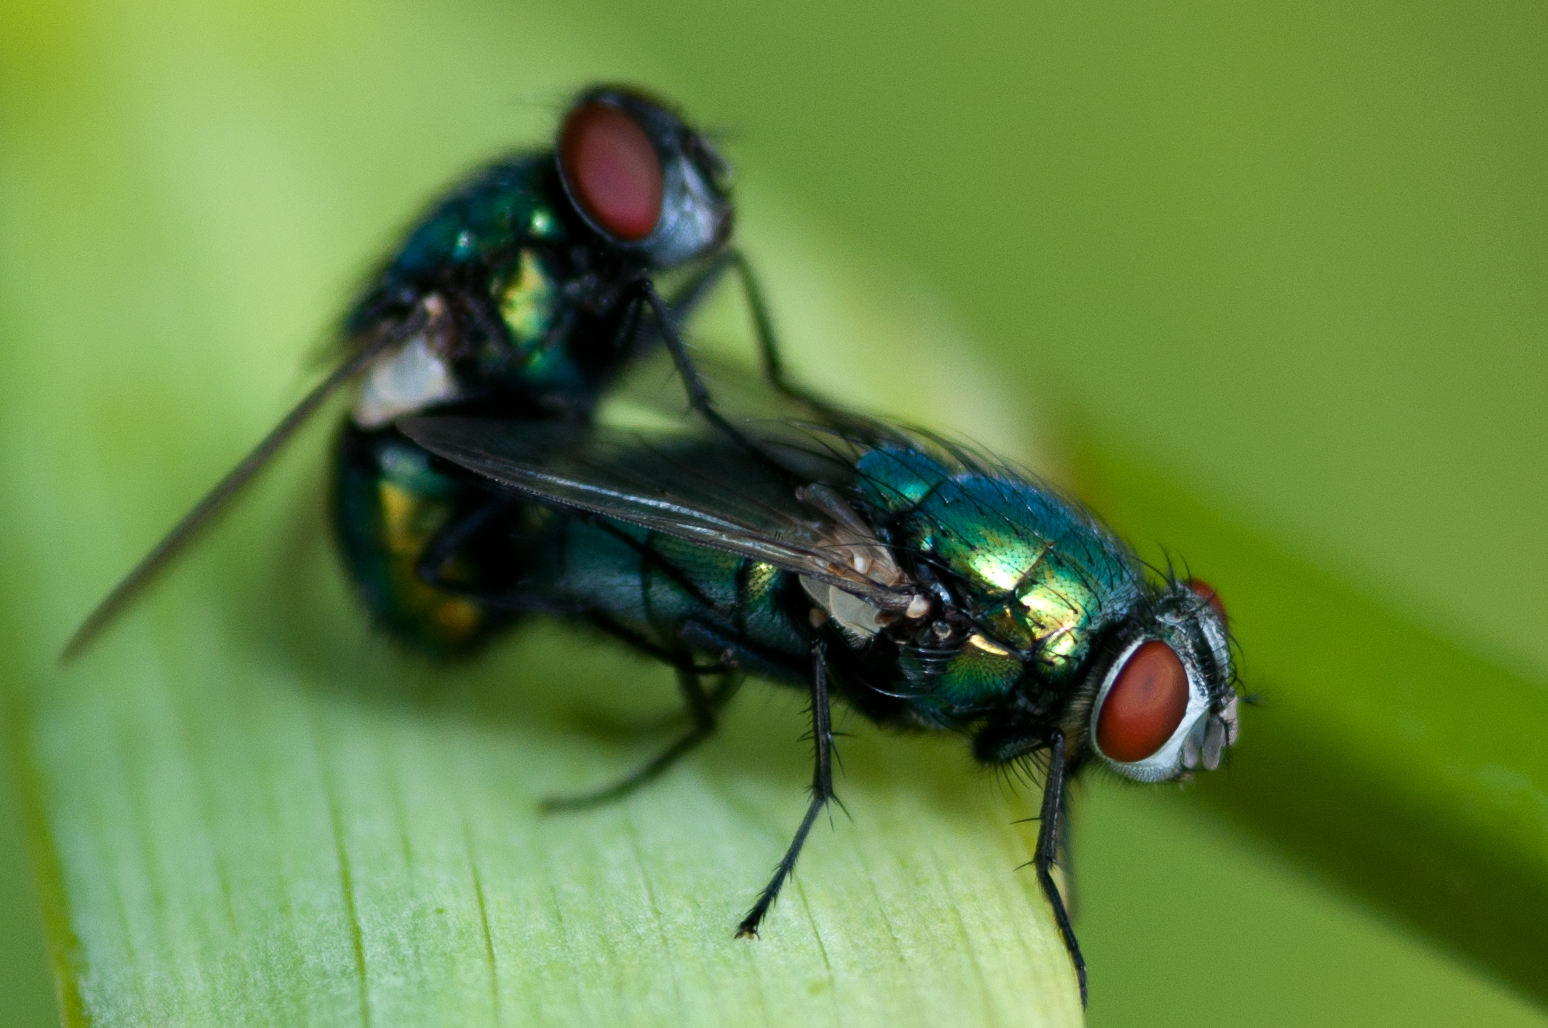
[401,416,1237,1002]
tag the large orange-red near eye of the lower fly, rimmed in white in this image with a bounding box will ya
[1096,641,1187,763]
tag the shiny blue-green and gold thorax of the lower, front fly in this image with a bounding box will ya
[858,447,1142,708]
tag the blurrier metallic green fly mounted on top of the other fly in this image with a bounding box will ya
[62,85,794,661]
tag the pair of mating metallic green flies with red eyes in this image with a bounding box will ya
[65,87,1237,997]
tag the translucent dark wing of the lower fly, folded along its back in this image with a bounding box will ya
[398,416,915,610]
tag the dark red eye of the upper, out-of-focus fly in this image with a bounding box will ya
[559,104,661,243]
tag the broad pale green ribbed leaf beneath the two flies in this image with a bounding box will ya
[0,6,1081,1026]
